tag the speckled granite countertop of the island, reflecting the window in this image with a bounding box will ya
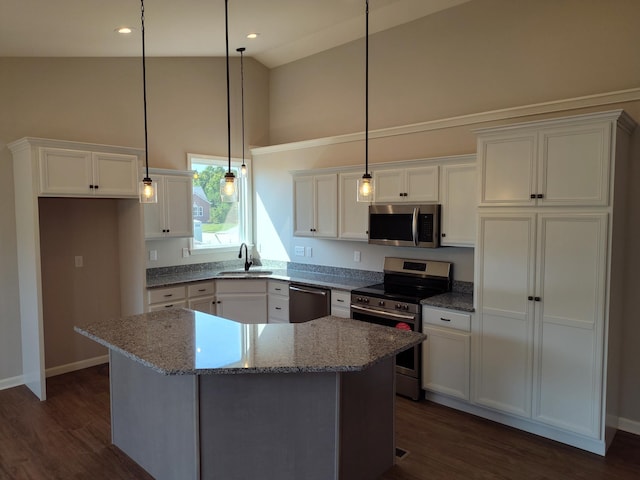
[74,308,426,375]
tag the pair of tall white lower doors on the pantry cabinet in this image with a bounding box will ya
[474,211,608,438]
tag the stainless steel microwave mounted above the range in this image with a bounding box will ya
[369,203,441,248]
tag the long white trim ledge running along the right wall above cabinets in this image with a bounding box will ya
[251,88,640,156]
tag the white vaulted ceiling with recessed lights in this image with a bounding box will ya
[0,0,469,68]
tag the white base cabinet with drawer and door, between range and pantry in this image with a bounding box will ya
[422,307,471,401]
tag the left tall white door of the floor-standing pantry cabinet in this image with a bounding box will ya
[473,213,536,417]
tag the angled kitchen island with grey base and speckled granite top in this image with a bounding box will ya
[75,308,426,480]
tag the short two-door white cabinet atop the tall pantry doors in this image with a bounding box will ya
[478,114,615,206]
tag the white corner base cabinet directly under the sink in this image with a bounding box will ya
[216,279,267,323]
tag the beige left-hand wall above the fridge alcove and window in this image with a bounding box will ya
[0,54,269,380]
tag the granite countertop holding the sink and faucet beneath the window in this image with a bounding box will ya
[147,267,376,290]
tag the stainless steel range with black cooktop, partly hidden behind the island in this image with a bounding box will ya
[351,257,453,400]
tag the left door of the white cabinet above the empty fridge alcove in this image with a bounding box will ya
[39,148,93,196]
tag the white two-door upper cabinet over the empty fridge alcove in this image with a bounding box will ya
[39,148,138,198]
